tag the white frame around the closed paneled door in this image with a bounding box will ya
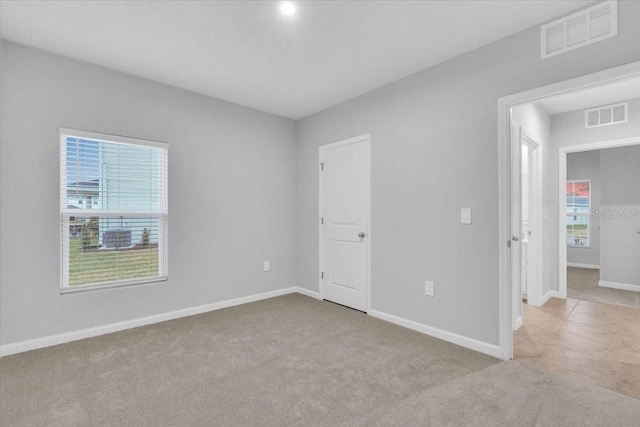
[317,133,371,313]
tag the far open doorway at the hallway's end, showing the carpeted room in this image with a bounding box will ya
[558,140,640,300]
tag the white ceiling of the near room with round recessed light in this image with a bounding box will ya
[0,0,591,119]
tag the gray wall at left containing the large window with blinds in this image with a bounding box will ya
[0,41,296,344]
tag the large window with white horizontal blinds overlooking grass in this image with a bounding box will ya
[60,129,168,291]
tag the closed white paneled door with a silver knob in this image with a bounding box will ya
[320,135,370,311]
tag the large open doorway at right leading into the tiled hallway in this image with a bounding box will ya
[501,63,640,398]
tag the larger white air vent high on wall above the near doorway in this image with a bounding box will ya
[540,0,618,59]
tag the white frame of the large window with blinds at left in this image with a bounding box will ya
[58,127,169,294]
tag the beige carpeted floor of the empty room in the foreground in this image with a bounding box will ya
[0,294,640,426]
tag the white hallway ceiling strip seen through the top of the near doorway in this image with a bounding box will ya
[538,78,640,115]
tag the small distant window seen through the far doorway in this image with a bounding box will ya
[567,179,591,247]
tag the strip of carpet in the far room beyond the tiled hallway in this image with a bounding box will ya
[567,267,640,309]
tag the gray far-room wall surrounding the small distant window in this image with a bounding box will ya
[568,150,601,266]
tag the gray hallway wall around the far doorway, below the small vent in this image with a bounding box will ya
[543,99,640,291]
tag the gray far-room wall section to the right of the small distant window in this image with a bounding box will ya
[600,145,640,286]
